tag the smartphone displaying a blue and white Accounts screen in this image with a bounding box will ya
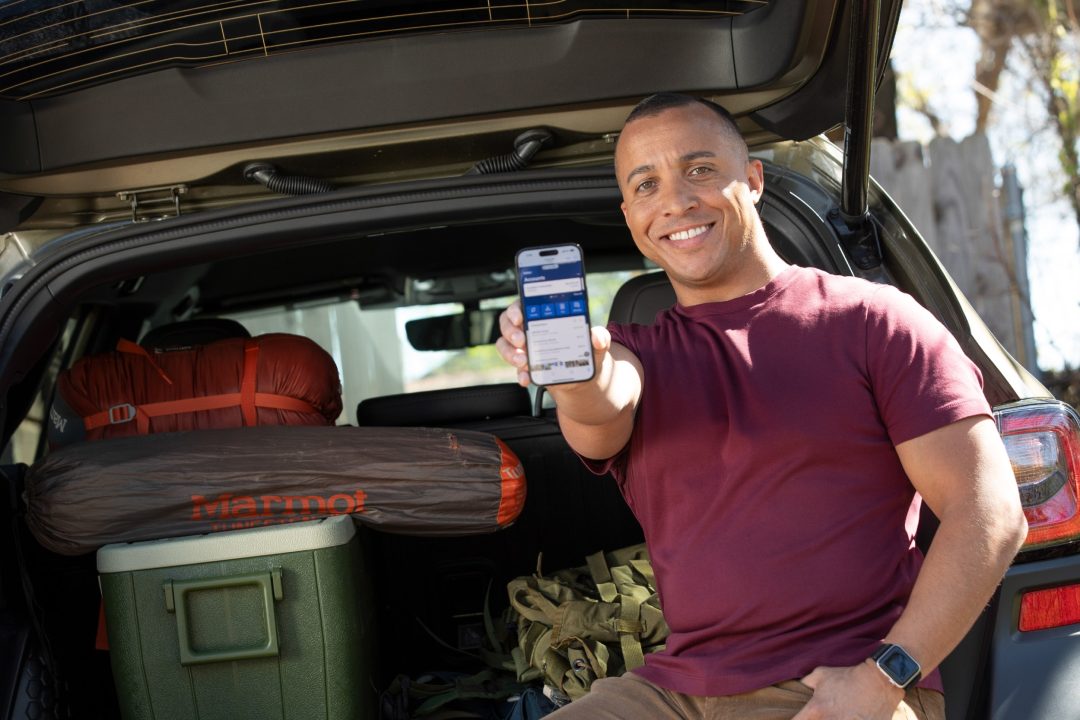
[514,244,596,385]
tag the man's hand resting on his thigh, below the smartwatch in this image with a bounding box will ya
[793,661,904,720]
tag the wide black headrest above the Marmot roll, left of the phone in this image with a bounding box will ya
[356,382,532,427]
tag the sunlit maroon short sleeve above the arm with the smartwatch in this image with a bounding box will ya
[866,286,990,445]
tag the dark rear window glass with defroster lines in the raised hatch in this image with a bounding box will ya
[0,0,767,99]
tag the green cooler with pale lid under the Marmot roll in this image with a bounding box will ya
[97,516,376,720]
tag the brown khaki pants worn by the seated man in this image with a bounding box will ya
[550,673,945,720]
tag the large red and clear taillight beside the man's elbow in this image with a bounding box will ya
[995,400,1080,549]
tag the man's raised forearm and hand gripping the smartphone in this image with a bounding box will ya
[496,301,642,460]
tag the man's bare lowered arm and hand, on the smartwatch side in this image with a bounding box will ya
[796,417,1027,720]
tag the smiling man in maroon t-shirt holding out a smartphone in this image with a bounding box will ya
[498,95,1026,720]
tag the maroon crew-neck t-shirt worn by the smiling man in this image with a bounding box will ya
[589,268,990,695]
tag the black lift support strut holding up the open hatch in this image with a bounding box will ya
[828,0,881,270]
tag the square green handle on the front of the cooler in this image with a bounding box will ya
[164,569,284,665]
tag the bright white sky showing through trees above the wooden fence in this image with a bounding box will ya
[892,0,1080,369]
